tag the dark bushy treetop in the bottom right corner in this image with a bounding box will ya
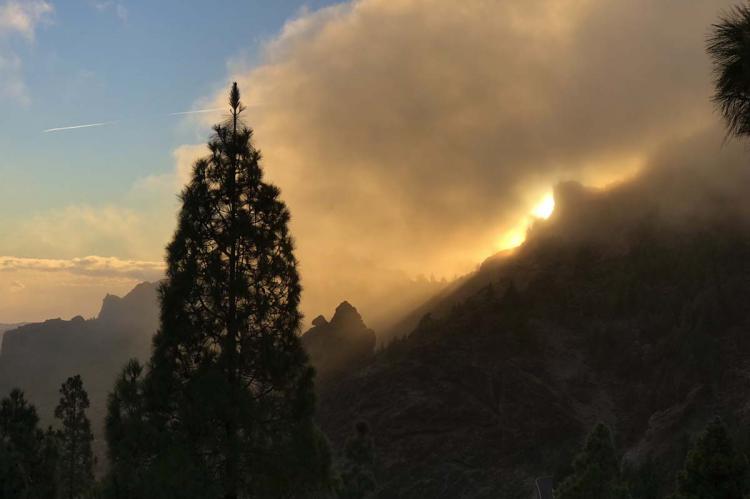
[674,418,750,499]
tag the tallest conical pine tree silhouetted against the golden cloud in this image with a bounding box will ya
[145,83,331,499]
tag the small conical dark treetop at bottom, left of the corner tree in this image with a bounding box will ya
[555,423,630,499]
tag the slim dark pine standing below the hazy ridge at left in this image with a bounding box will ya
[55,375,94,499]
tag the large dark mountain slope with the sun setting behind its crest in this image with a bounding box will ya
[320,171,750,499]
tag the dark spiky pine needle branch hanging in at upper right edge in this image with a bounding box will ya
[708,5,750,136]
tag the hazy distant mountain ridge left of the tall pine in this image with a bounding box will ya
[0,283,158,468]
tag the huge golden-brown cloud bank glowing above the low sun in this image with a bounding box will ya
[185,0,731,320]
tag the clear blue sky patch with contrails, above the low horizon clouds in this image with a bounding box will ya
[0,0,336,221]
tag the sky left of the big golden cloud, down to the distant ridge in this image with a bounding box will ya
[0,0,340,322]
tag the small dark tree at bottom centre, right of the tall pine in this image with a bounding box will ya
[339,421,376,499]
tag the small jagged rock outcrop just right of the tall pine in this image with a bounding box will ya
[302,301,376,384]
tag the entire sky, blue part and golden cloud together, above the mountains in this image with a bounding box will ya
[0,0,744,323]
